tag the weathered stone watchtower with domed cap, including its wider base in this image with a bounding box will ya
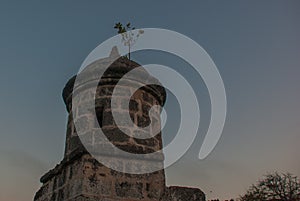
[34,49,205,201]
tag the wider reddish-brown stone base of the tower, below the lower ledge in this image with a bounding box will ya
[34,153,164,201]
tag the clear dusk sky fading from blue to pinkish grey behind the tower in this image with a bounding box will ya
[0,0,300,201]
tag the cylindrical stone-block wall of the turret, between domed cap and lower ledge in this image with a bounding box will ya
[65,80,162,156]
